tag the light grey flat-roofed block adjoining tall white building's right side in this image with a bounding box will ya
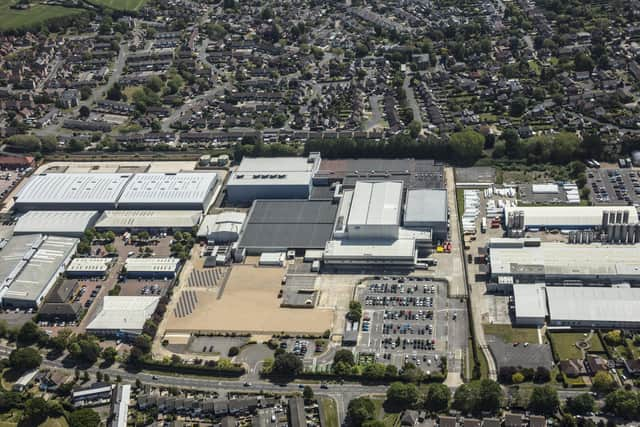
[403,189,449,240]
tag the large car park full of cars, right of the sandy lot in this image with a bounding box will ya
[358,276,466,371]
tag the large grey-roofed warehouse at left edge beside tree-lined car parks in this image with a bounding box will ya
[0,235,79,308]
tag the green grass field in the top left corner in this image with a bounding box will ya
[0,0,85,32]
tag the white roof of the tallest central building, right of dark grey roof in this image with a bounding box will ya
[347,181,402,226]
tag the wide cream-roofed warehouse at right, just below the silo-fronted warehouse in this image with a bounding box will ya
[488,238,640,286]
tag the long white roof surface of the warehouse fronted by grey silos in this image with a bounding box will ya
[504,206,638,228]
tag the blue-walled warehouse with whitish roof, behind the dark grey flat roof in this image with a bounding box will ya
[226,153,320,204]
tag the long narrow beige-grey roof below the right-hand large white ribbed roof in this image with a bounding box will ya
[96,210,202,229]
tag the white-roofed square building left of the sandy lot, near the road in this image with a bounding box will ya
[87,296,160,334]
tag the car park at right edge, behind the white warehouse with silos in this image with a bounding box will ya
[587,169,640,205]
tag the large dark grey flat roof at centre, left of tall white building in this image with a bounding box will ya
[240,200,338,249]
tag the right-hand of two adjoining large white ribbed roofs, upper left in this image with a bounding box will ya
[118,172,217,208]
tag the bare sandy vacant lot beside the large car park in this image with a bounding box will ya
[166,265,333,335]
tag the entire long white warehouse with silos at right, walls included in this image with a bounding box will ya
[504,206,638,230]
